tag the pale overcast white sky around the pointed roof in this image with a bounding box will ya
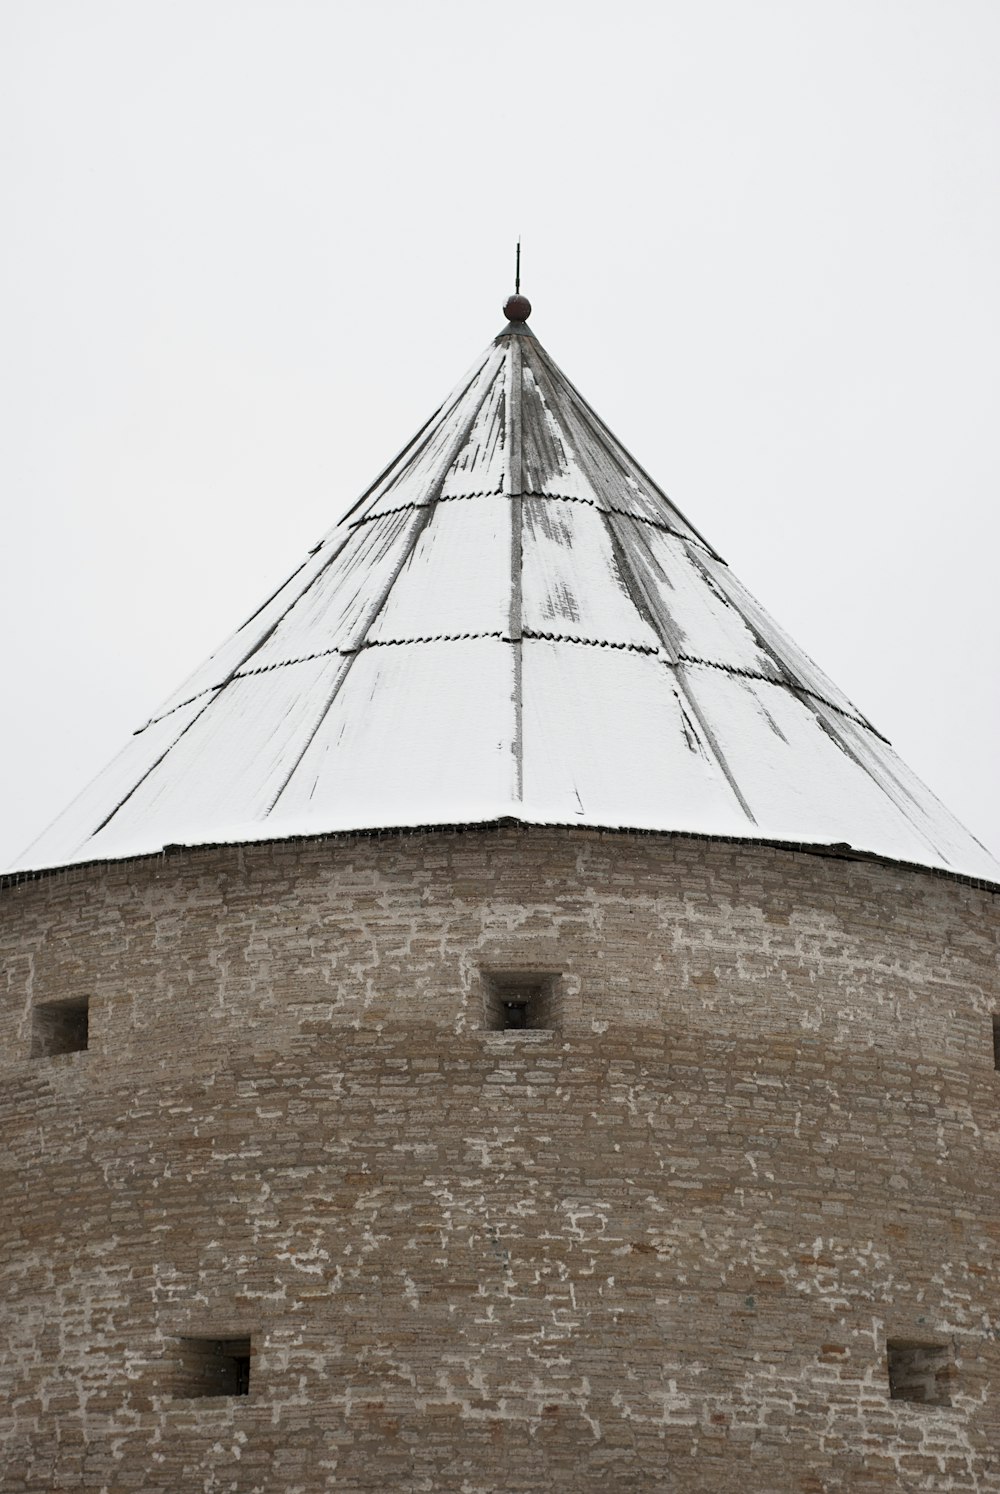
[0,0,1000,864]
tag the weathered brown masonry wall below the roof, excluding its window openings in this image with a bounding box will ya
[0,829,1000,1494]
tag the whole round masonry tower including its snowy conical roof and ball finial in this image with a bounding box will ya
[0,285,1000,1494]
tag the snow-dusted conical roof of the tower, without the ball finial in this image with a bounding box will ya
[19,309,1000,881]
